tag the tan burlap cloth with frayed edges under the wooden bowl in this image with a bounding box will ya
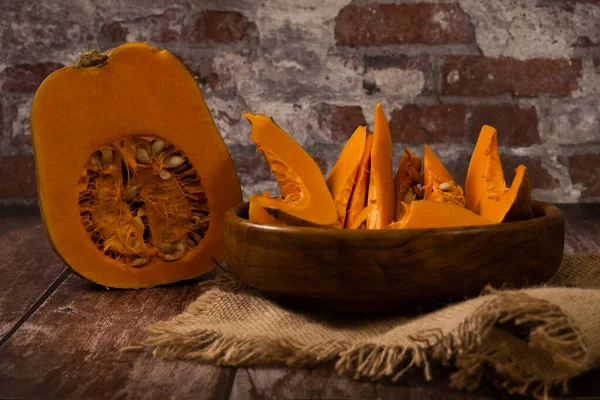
[129,254,600,397]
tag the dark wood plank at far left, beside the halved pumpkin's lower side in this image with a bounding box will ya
[0,206,66,342]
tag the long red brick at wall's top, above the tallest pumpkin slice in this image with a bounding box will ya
[335,3,475,47]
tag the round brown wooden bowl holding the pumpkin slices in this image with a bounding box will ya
[223,202,564,312]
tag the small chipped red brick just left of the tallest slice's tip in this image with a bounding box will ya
[318,103,367,142]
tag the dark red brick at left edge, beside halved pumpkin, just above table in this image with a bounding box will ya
[0,156,37,199]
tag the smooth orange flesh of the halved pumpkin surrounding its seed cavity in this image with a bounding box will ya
[31,43,242,288]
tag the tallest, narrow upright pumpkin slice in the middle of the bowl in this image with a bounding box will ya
[367,103,396,229]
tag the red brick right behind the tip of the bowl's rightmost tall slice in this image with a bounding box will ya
[471,105,542,147]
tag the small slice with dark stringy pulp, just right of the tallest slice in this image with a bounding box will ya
[394,146,423,219]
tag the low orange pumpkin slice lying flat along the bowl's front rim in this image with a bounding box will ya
[387,200,495,229]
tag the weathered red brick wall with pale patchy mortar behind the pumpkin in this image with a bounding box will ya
[0,0,600,202]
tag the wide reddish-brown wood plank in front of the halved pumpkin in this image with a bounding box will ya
[0,275,233,399]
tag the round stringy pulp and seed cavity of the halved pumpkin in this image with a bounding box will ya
[78,136,209,267]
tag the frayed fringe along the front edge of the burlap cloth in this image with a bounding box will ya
[124,273,589,398]
